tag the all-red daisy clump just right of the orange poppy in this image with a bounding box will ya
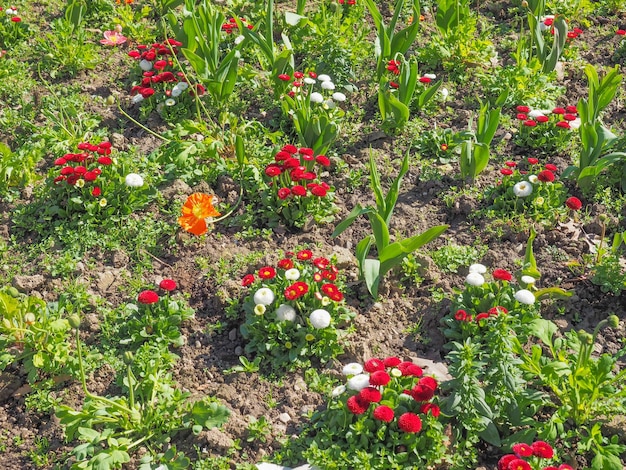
[262,145,337,228]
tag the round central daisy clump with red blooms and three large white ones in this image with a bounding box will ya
[241,250,354,370]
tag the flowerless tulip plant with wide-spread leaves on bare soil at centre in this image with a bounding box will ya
[332,153,448,298]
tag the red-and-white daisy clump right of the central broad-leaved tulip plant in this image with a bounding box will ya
[443,263,539,339]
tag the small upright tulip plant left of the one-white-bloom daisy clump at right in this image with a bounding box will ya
[459,90,508,181]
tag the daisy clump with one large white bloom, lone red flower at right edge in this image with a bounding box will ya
[487,157,582,225]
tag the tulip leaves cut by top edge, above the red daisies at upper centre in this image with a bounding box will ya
[365,0,420,82]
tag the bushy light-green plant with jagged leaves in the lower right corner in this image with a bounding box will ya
[516,315,626,470]
